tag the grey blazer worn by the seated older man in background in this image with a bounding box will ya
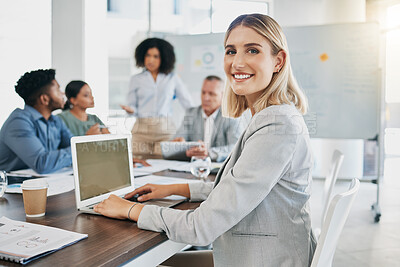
[175,106,244,162]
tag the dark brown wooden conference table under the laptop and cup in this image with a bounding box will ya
[0,171,215,267]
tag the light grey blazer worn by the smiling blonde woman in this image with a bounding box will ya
[138,105,315,267]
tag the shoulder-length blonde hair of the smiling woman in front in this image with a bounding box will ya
[222,14,308,118]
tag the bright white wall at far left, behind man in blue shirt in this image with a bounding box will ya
[0,0,51,127]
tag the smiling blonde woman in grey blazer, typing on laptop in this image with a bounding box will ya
[95,14,315,266]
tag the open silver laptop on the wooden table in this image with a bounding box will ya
[71,134,184,214]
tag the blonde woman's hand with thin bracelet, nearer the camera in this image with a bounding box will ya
[93,195,143,221]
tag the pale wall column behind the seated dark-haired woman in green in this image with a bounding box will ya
[52,0,108,119]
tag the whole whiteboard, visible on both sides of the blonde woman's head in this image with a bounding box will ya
[166,23,380,139]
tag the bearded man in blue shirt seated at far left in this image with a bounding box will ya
[0,69,72,173]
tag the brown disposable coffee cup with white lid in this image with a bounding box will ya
[22,178,49,217]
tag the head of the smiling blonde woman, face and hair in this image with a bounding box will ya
[224,16,307,117]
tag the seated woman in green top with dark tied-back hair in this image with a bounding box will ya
[58,81,110,136]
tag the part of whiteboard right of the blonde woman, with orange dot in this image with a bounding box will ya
[284,23,380,139]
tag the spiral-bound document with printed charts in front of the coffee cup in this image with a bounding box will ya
[0,216,88,264]
